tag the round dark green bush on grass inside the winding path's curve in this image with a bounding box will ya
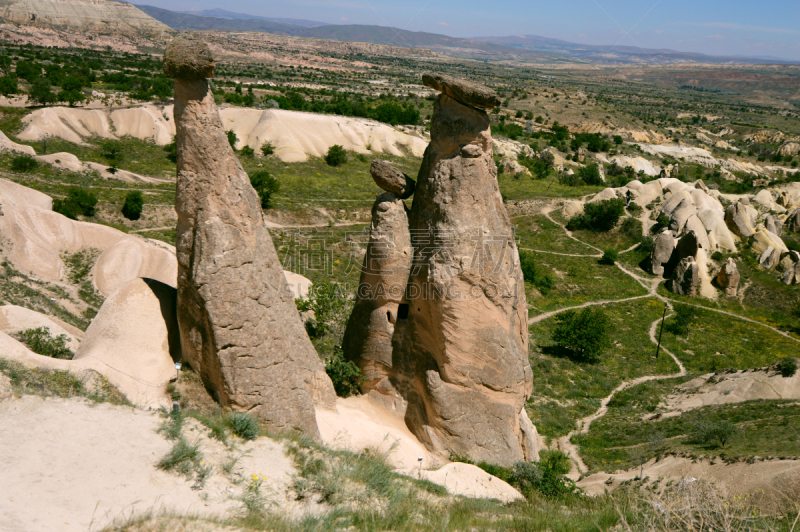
[553,307,611,360]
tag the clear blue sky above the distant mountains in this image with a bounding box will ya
[147,0,800,60]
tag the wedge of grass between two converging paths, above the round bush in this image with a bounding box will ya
[528,252,655,319]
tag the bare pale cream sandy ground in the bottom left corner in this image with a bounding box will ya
[0,396,300,532]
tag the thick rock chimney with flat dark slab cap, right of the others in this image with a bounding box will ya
[394,75,538,465]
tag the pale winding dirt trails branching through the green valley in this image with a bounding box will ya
[528,202,800,480]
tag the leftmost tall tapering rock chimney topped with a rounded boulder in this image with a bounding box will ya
[164,34,335,438]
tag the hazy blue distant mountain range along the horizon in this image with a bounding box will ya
[137,5,795,65]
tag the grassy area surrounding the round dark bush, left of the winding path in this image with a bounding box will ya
[527,298,678,438]
